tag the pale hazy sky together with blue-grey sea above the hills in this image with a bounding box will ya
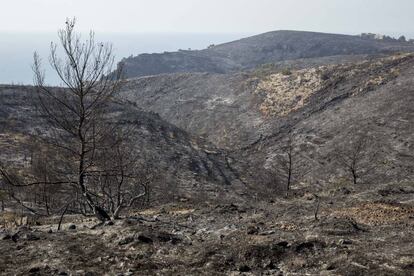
[0,0,414,84]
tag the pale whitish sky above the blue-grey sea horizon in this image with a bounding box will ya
[0,0,414,34]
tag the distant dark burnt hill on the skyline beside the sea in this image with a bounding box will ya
[122,31,414,78]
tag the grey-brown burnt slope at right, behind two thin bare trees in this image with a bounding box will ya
[237,53,414,188]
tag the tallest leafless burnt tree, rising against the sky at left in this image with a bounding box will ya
[33,19,122,220]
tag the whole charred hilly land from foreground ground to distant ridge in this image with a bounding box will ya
[0,31,414,275]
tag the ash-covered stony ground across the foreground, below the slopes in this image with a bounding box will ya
[0,182,414,275]
